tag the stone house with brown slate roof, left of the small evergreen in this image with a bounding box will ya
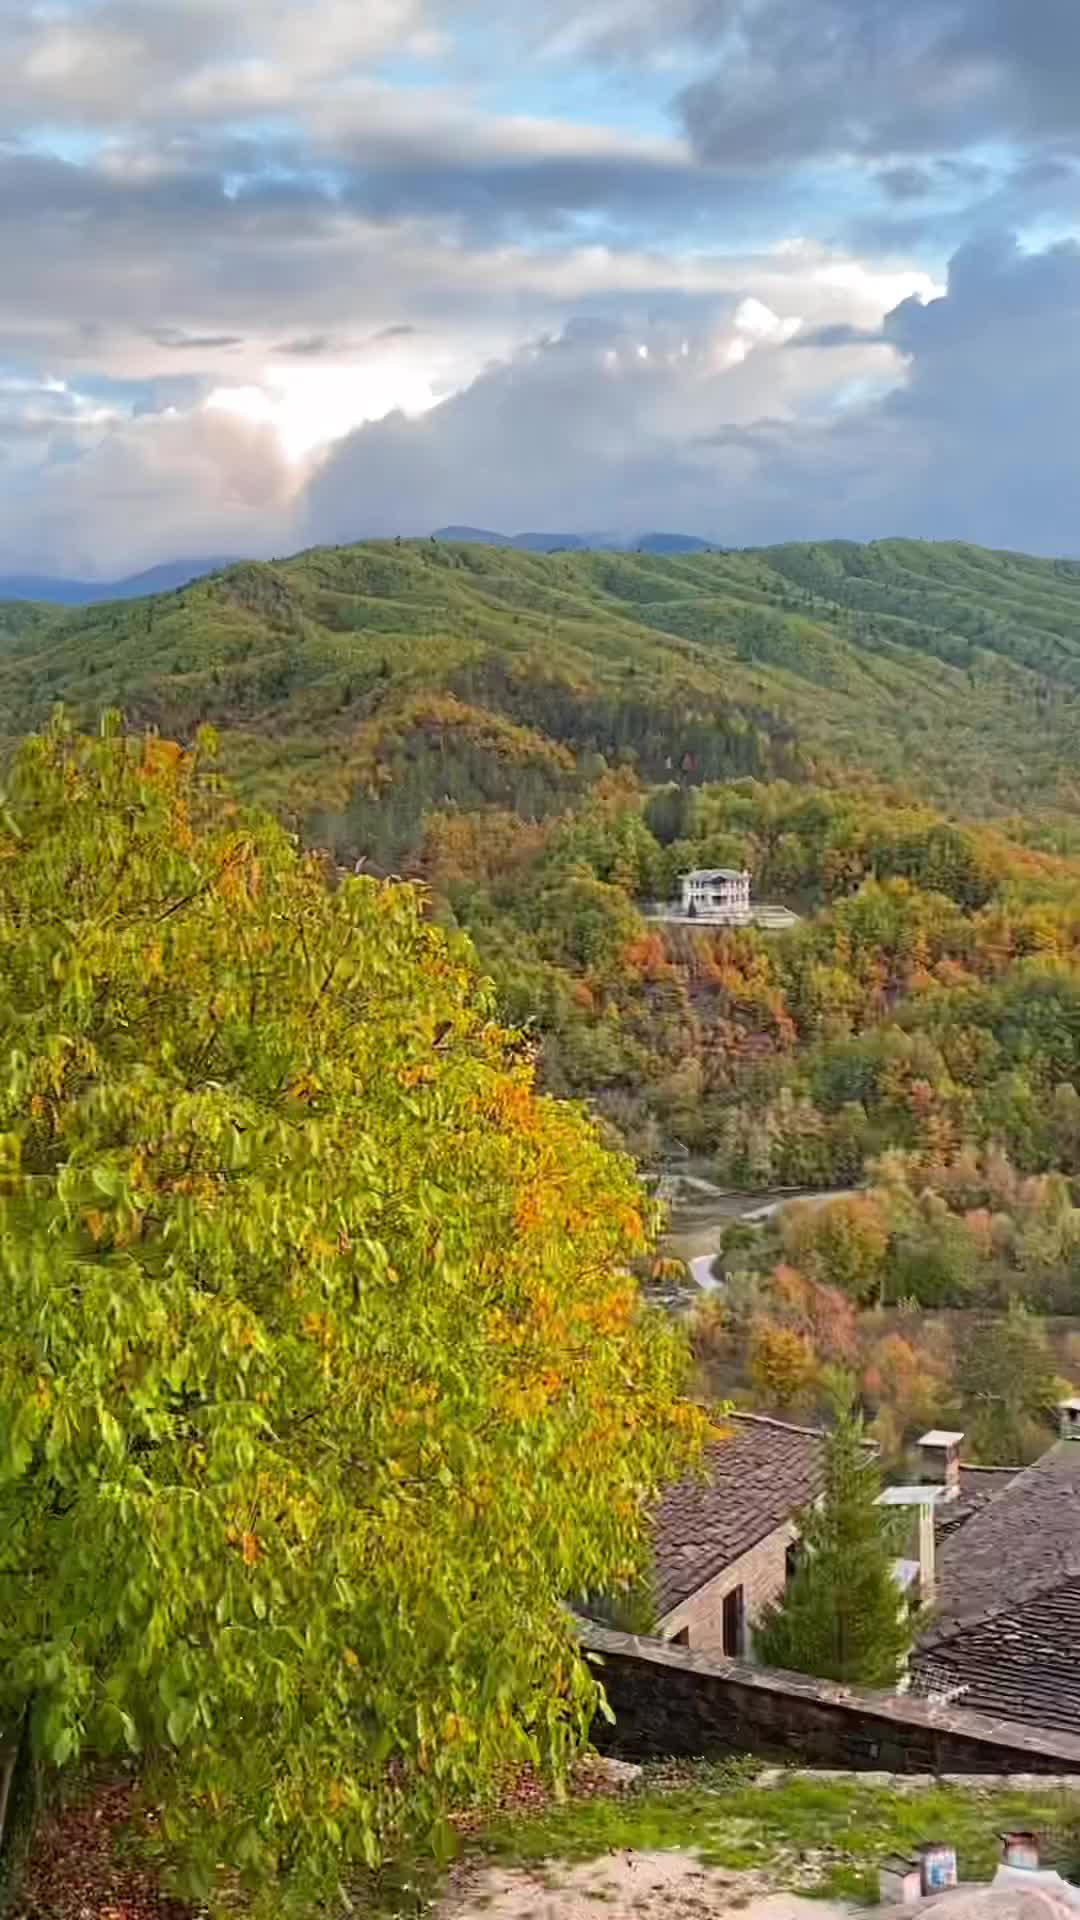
[641,1413,826,1659]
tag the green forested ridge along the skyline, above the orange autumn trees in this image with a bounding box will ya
[0,541,1080,852]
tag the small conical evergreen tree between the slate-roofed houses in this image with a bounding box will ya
[753,1411,911,1688]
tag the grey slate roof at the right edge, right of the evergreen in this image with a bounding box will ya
[915,1442,1080,1732]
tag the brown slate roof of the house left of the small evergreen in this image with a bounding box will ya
[653,1413,822,1617]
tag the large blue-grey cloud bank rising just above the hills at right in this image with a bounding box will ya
[295,240,1080,555]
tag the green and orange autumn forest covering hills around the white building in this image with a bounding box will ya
[10,541,1080,1457]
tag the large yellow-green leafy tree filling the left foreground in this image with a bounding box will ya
[0,724,698,1912]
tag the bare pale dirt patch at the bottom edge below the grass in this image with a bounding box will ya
[436,1853,855,1920]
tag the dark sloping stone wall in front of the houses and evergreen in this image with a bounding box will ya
[580,1622,1080,1774]
